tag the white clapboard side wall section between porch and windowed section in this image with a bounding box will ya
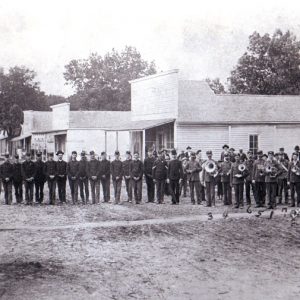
[175,125,229,160]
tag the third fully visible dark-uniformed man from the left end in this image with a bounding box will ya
[22,153,36,205]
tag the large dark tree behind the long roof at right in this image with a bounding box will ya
[228,29,300,95]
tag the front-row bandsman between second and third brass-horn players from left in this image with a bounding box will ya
[252,151,266,207]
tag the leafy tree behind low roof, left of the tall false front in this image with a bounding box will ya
[64,46,156,110]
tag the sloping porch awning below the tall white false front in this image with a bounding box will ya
[103,119,175,131]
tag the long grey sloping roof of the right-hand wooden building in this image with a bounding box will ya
[178,81,300,124]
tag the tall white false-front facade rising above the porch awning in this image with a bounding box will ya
[131,72,178,121]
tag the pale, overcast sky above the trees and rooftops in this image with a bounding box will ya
[0,0,300,96]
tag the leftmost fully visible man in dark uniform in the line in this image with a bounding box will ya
[0,153,14,205]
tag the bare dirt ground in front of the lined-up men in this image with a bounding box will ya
[0,184,300,300]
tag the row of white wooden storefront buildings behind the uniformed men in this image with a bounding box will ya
[10,70,300,158]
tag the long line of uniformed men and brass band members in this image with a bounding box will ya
[0,145,300,208]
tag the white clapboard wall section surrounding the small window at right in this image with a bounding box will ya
[229,125,276,152]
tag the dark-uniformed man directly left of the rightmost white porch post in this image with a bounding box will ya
[129,152,144,204]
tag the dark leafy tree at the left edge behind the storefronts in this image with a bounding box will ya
[0,67,47,138]
